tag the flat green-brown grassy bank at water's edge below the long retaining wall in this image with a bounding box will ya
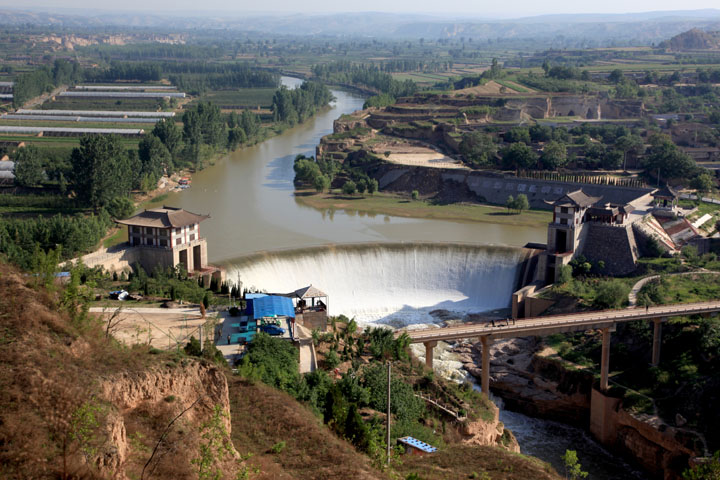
[295,190,552,228]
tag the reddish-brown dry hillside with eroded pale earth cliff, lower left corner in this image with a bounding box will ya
[0,264,242,479]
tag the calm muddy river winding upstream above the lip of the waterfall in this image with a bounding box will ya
[158,77,545,264]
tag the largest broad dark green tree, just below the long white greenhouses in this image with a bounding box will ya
[71,135,132,210]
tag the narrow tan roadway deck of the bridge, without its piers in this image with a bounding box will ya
[396,301,720,343]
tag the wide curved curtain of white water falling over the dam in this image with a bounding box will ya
[226,243,528,327]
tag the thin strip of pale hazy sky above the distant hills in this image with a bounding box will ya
[0,0,720,18]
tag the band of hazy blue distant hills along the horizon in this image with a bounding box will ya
[0,8,720,48]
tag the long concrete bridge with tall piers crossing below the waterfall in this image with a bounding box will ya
[395,301,720,393]
